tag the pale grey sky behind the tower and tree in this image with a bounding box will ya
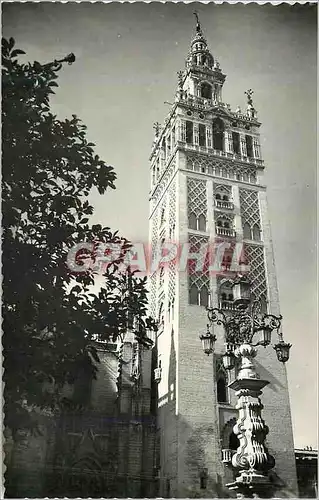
[2,2,318,448]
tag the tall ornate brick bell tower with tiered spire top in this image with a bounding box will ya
[149,14,297,498]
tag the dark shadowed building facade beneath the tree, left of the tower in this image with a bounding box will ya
[4,338,158,498]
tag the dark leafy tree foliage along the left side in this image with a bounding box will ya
[2,38,156,427]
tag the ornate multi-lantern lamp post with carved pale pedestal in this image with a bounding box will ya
[200,276,291,497]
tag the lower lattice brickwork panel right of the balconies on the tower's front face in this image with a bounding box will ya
[244,244,268,299]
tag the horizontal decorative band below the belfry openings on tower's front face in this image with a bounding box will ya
[186,155,257,184]
